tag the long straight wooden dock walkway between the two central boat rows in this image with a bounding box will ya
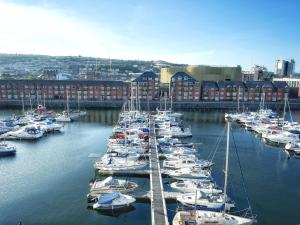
[149,116,169,225]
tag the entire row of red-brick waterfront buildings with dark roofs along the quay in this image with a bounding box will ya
[0,75,290,102]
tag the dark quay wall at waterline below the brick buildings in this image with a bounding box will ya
[0,99,300,111]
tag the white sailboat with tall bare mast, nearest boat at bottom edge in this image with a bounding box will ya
[173,122,255,225]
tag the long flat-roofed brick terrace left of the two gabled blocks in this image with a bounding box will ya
[0,80,128,101]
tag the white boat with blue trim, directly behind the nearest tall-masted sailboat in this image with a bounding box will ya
[176,191,235,211]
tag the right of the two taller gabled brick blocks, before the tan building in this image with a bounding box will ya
[169,72,201,101]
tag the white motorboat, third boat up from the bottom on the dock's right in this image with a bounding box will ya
[170,180,223,194]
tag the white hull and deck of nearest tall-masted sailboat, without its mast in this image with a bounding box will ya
[173,210,255,225]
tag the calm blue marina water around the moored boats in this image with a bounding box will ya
[0,110,300,225]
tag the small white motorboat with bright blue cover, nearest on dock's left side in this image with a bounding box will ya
[93,192,135,210]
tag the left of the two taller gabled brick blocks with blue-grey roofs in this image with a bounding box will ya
[130,71,159,100]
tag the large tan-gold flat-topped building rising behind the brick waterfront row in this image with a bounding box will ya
[160,65,242,84]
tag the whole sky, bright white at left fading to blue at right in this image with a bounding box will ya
[0,0,300,72]
